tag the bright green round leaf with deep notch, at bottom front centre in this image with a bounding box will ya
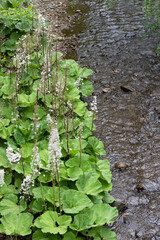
[34,211,72,234]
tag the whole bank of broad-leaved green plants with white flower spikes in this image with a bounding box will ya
[0,0,118,240]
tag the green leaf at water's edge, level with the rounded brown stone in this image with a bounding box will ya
[97,159,112,183]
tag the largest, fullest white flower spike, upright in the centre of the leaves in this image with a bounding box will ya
[48,122,62,170]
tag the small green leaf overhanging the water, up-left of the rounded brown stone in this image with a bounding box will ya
[88,137,106,155]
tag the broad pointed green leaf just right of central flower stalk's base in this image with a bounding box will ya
[62,189,93,213]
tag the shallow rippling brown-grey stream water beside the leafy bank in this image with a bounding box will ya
[64,0,160,240]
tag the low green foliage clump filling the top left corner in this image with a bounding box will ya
[0,0,35,69]
